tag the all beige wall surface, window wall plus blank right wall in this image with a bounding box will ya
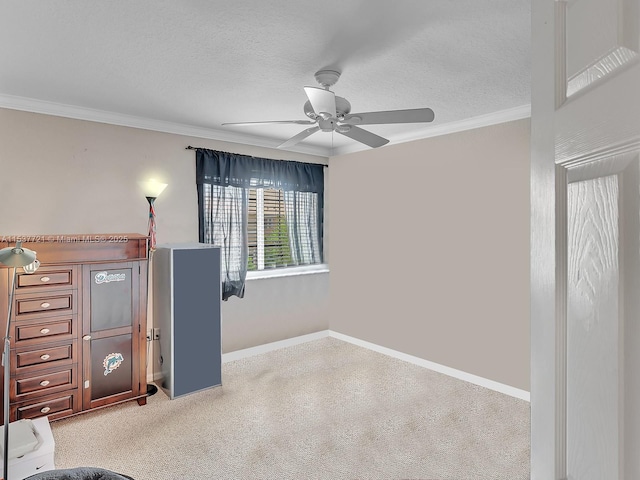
[0,109,529,390]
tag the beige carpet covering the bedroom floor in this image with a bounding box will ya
[52,338,529,480]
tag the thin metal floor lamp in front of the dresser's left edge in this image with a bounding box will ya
[0,242,40,480]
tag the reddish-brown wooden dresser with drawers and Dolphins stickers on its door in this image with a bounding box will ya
[0,234,148,422]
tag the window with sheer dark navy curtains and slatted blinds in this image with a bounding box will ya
[196,149,324,299]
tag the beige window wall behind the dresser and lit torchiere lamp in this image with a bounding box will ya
[0,109,329,362]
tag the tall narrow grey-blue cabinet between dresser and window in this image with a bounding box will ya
[151,243,222,399]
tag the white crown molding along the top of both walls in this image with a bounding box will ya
[0,94,531,157]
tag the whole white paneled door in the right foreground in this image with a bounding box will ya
[531,0,640,480]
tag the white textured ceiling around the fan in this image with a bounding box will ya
[0,0,530,155]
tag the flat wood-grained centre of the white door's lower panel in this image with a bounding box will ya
[566,171,620,480]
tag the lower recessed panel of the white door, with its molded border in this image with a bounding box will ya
[559,153,640,480]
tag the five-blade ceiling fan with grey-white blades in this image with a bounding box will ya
[222,70,434,148]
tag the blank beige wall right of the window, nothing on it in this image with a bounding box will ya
[329,119,530,390]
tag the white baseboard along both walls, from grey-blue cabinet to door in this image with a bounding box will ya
[222,330,531,402]
